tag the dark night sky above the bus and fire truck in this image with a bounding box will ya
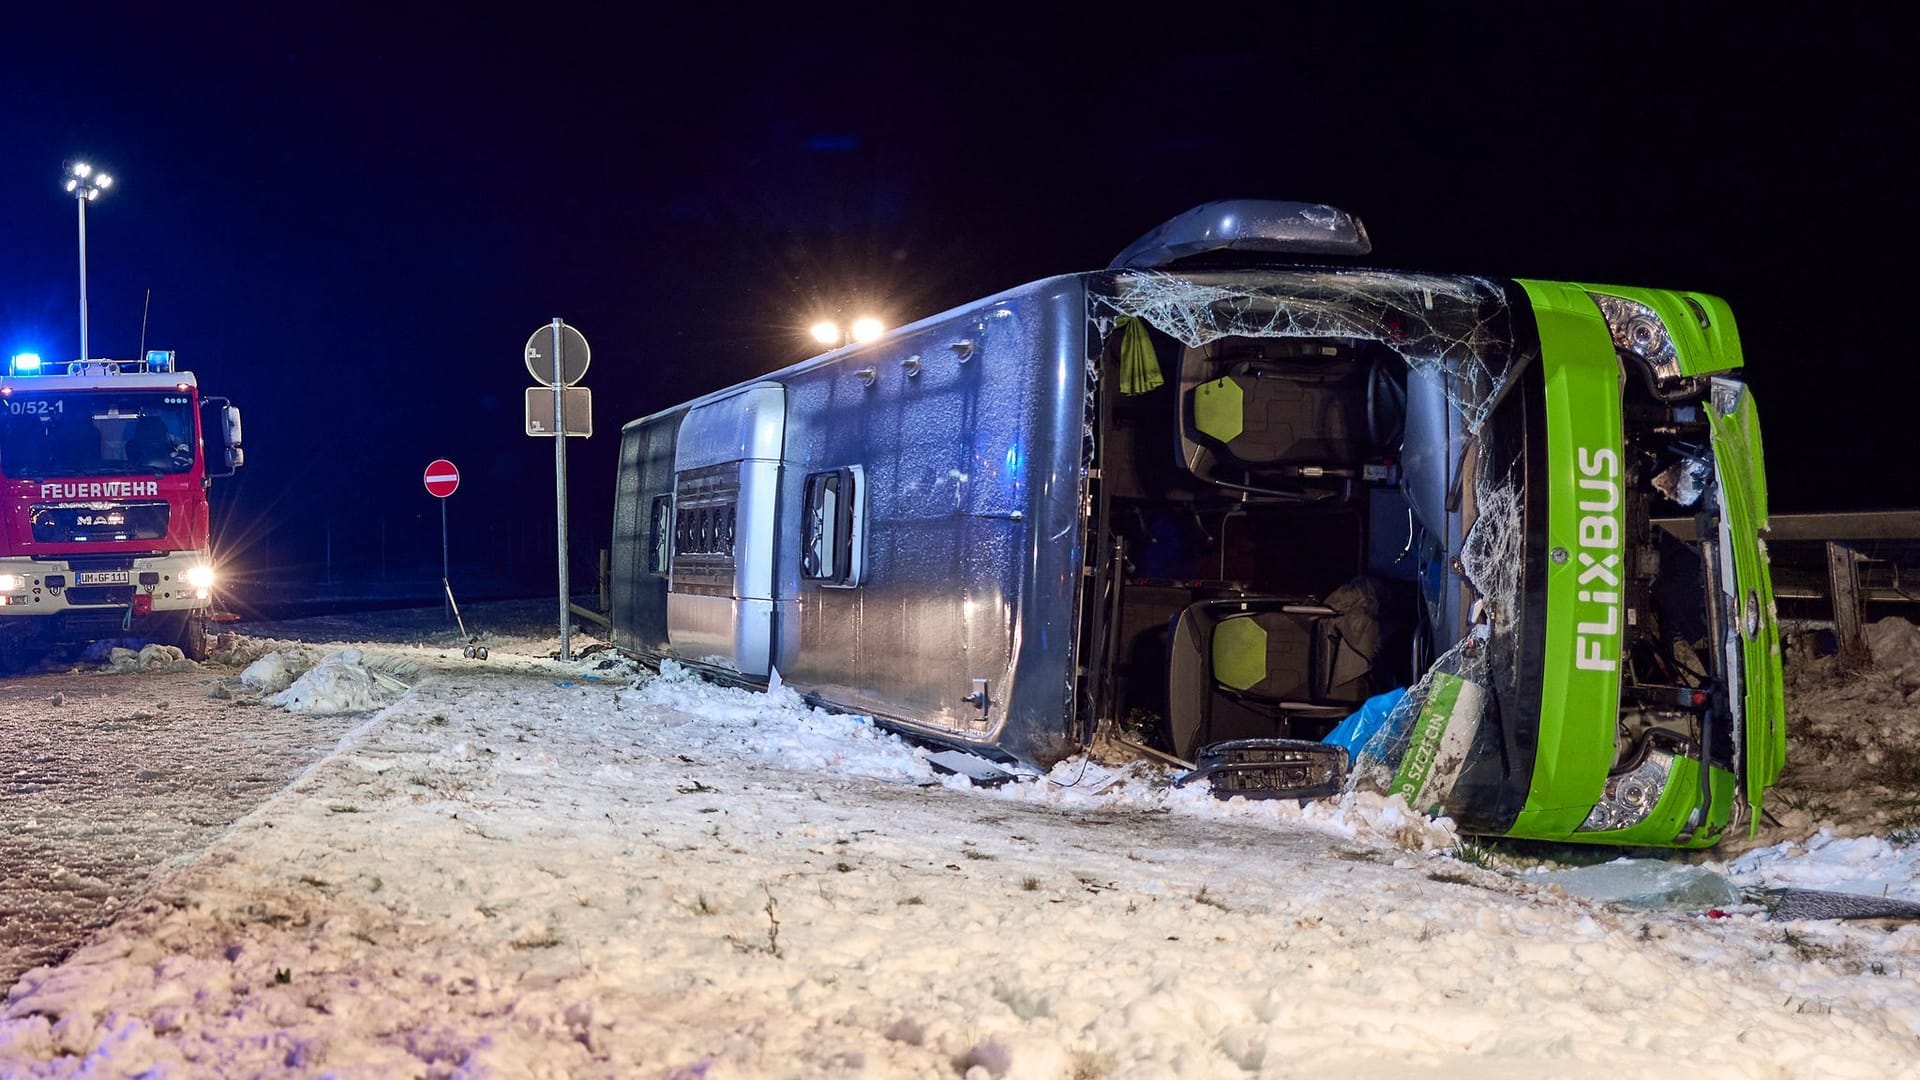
[0,4,1920,592]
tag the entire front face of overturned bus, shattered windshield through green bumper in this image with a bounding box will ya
[1079,259,1786,846]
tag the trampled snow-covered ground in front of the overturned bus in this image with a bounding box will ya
[0,607,1920,1080]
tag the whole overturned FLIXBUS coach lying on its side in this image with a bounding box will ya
[612,200,1786,846]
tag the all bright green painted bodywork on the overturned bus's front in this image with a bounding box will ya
[1482,281,1786,847]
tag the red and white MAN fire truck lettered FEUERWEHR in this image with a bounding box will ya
[0,350,244,675]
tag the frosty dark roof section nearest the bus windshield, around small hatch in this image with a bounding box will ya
[780,279,1085,759]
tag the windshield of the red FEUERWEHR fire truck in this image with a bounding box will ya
[0,388,196,479]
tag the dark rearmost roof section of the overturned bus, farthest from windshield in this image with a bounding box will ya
[611,411,682,655]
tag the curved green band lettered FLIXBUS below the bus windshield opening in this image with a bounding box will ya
[1507,281,1626,840]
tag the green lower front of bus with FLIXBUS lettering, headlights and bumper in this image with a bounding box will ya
[1497,281,1786,847]
